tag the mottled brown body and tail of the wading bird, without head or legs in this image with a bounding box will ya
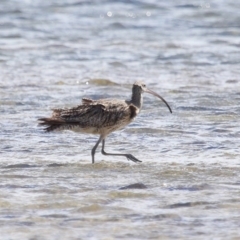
[39,98,138,135]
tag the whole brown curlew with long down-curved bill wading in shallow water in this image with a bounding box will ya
[38,81,172,163]
